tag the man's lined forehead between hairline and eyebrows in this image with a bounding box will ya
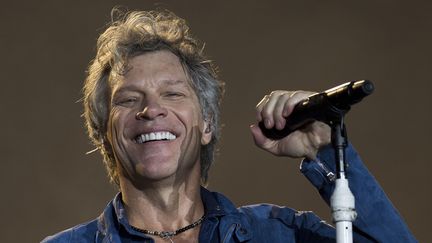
[112,50,191,90]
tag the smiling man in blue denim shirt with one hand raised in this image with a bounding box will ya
[44,11,415,242]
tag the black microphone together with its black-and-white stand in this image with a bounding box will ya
[259,80,374,243]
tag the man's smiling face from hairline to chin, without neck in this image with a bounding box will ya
[108,51,211,182]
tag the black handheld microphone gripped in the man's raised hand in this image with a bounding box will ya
[258,80,374,140]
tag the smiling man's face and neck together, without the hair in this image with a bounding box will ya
[107,50,212,240]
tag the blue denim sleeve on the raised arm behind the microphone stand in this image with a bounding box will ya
[300,144,417,243]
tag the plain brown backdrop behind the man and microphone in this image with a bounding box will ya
[0,0,432,242]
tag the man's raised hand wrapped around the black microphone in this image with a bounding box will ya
[251,90,331,159]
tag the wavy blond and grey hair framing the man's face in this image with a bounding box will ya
[83,9,223,185]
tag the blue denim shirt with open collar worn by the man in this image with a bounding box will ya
[42,145,417,243]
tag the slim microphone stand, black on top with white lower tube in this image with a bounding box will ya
[328,115,357,243]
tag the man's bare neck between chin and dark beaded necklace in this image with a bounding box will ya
[120,171,204,231]
